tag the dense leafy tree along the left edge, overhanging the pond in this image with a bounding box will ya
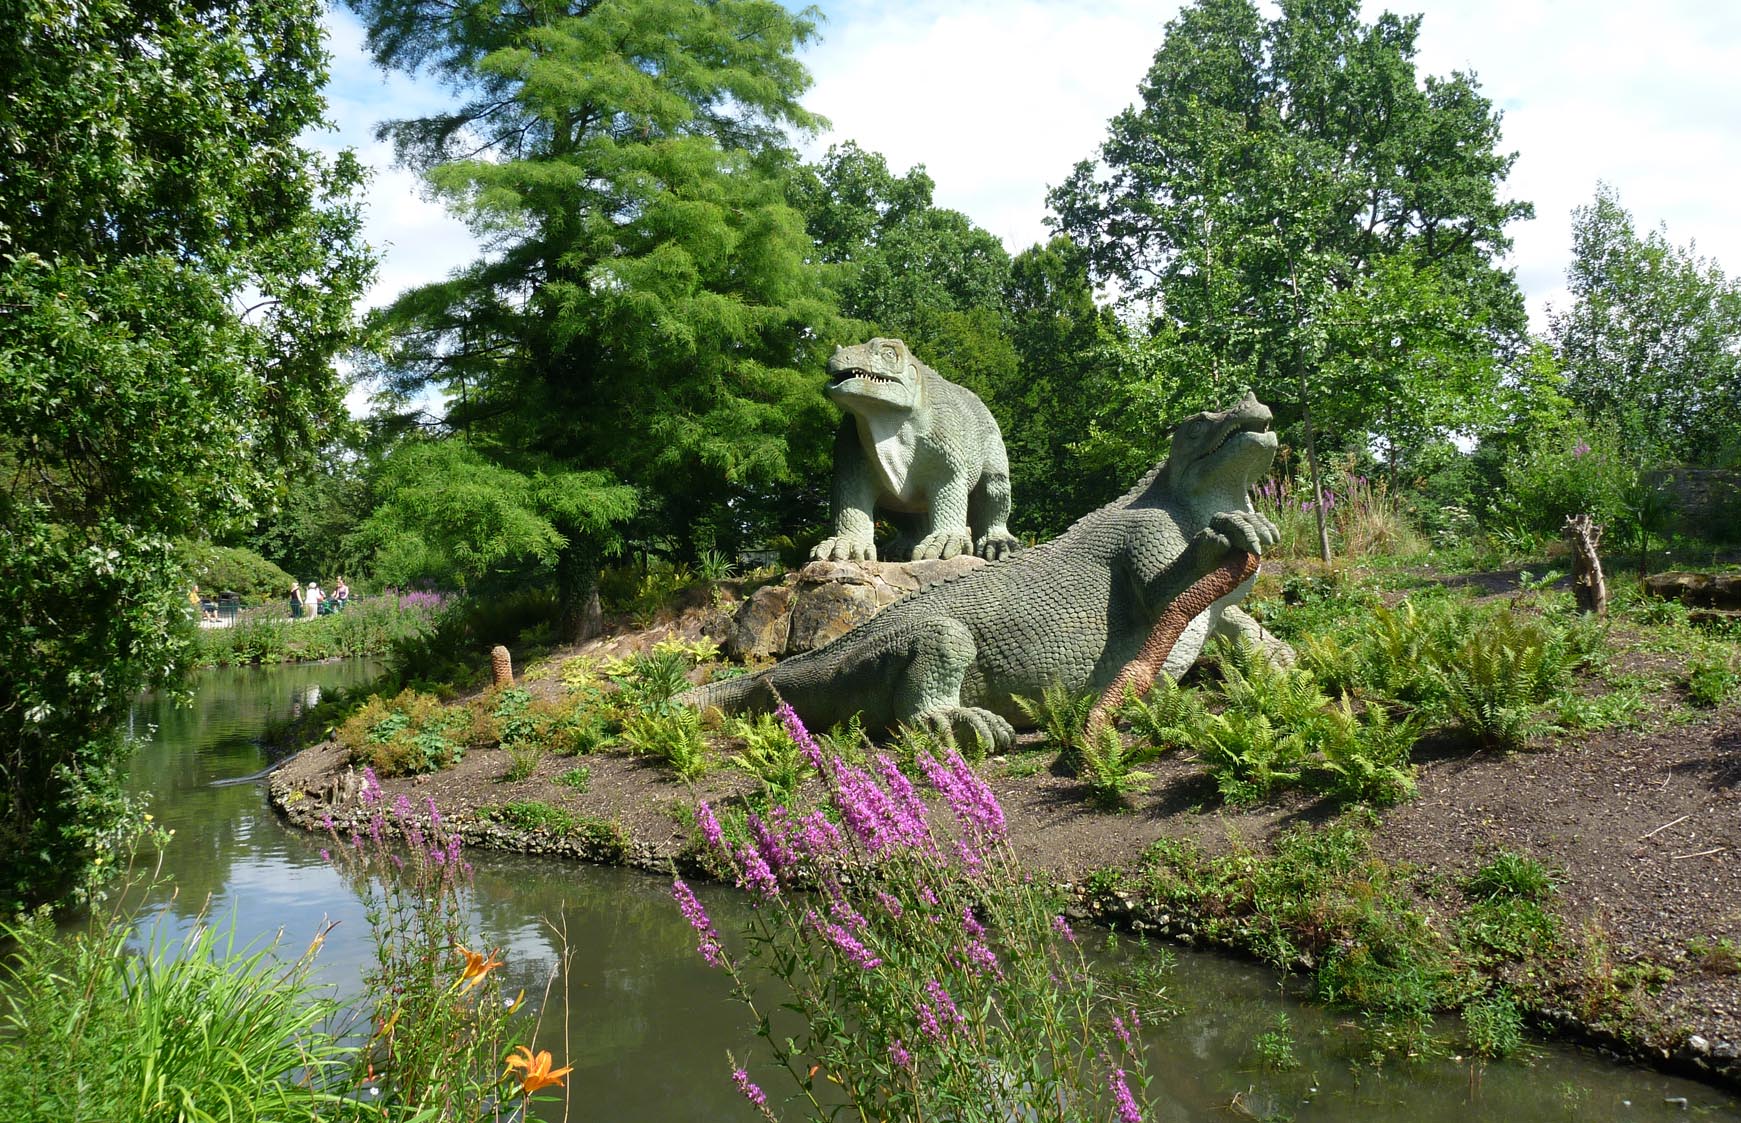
[0,0,373,914]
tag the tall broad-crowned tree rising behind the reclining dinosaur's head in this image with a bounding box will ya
[1050,0,1530,555]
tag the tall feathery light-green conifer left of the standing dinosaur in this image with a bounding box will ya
[353,0,834,637]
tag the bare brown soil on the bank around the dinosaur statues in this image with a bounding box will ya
[272,574,1741,1083]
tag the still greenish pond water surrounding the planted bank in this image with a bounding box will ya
[132,660,1741,1123]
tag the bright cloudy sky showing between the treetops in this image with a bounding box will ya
[319,0,1741,339]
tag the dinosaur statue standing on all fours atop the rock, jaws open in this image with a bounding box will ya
[811,332,1017,561]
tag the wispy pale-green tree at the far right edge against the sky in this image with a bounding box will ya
[1549,185,1741,465]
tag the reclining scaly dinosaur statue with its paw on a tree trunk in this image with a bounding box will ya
[684,395,1276,749]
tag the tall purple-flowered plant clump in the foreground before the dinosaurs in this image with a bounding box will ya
[672,709,1146,1120]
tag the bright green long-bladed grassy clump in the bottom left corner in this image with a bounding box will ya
[0,912,350,1123]
